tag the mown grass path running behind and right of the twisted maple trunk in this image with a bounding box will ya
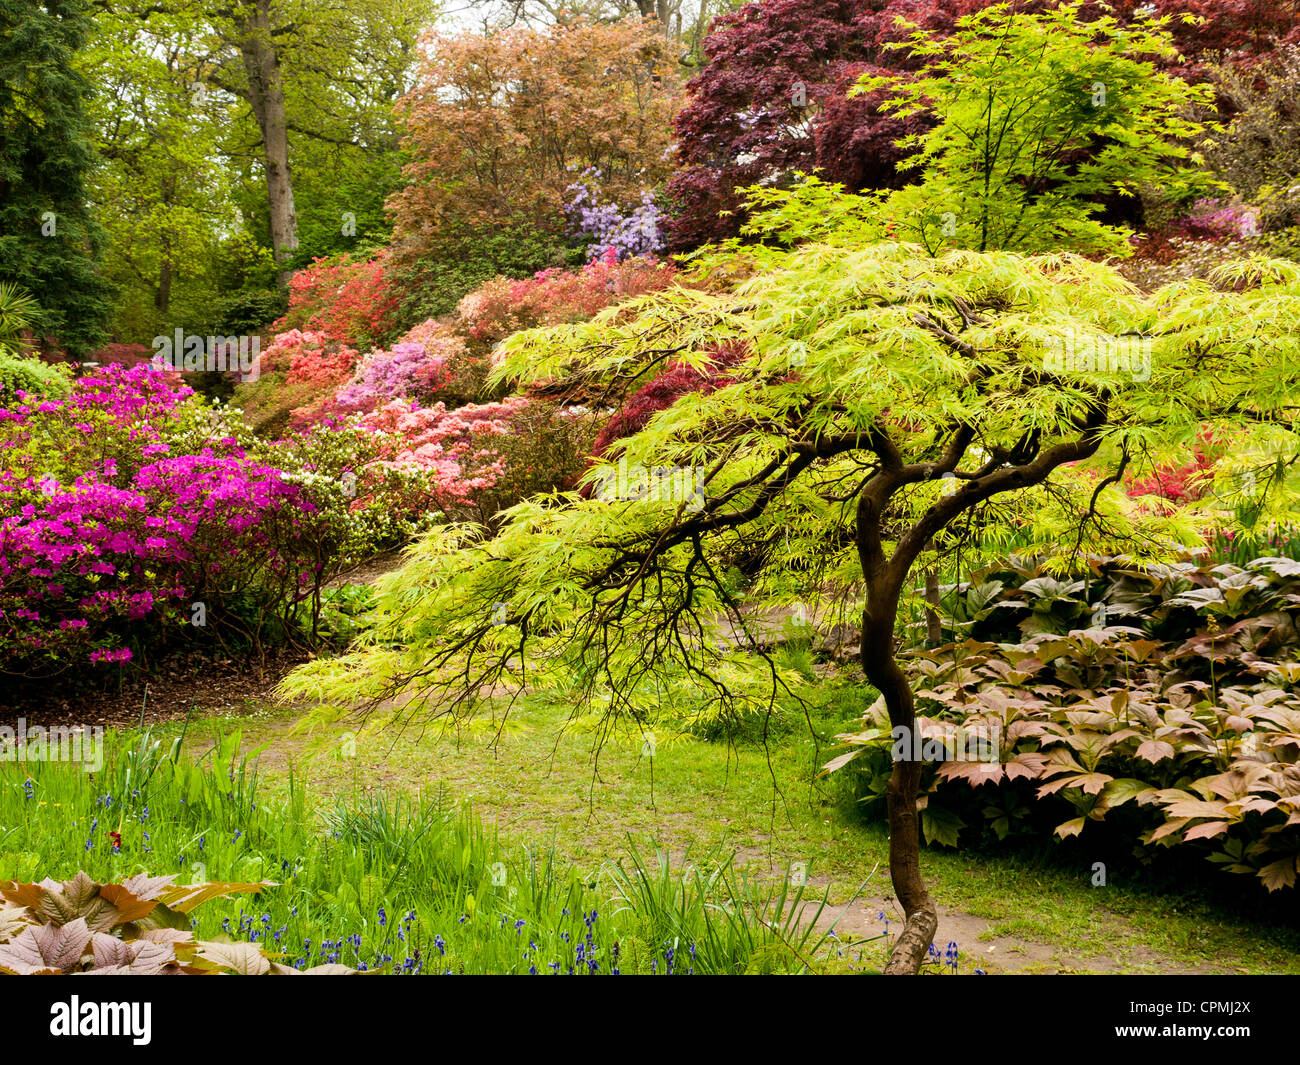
[154,697,1300,973]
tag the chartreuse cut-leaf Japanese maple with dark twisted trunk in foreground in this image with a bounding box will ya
[283,193,1300,969]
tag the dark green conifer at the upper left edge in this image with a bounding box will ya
[0,0,112,355]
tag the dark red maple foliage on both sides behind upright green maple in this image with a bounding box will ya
[670,0,1300,250]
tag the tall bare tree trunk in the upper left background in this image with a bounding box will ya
[235,0,298,286]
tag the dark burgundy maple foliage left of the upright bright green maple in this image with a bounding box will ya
[668,0,985,250]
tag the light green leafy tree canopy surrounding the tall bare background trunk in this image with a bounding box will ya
[79,0,436,343]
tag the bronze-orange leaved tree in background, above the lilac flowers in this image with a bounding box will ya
[390,21,675,270]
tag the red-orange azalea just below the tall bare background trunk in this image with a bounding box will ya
[274,252,398,346]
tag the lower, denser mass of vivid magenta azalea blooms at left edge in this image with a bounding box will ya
[0,453,313,675]
